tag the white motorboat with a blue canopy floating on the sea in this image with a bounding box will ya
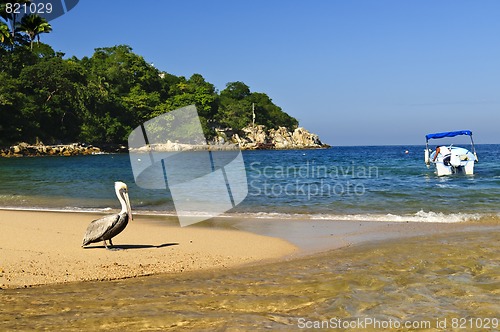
[424,130,478,176]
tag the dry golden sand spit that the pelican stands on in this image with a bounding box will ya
[0,210,297,288]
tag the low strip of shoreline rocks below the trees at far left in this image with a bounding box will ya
[0,143,102,157]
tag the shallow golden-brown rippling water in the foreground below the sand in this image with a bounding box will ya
[0,230,500,331]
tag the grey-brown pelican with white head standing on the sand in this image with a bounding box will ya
[82,181,134,249]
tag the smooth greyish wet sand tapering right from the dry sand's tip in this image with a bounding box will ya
[227,219,499,257]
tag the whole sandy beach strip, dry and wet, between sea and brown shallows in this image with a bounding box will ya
[0,210,499,288]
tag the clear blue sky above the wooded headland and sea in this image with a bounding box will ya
[42,0,500,145]
